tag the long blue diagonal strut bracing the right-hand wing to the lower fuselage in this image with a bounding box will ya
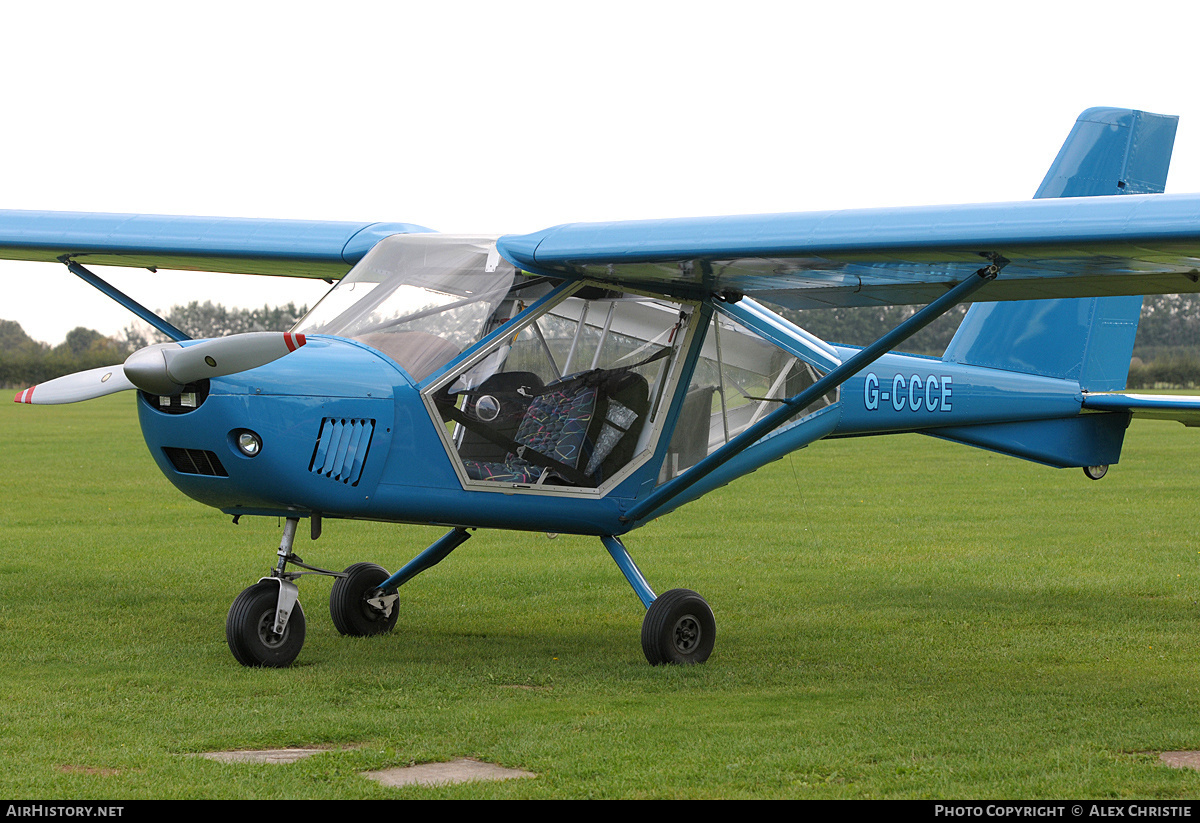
[620,253,1008,523]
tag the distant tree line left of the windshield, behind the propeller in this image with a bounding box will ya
[0,302,307,389]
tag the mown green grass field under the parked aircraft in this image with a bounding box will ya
[0,395,1200,799]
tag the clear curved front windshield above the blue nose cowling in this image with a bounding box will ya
[294,234,517,380]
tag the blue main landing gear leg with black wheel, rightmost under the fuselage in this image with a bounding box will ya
[600,535,716,666]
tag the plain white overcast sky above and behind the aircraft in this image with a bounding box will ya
[0,0,1200,343]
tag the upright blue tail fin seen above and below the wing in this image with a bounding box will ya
[943,108,1178,391]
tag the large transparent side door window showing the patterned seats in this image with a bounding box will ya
[428,289,691,491]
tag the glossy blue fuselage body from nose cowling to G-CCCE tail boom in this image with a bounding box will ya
[138,326,1108,544]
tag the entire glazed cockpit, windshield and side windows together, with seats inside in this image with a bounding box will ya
[294,234,836,495]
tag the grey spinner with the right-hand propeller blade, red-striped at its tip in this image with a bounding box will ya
[125,331,305,395]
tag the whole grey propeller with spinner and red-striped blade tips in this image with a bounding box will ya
[13,331,305,406]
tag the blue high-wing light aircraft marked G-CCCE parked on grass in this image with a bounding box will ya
[0,109,1200,666]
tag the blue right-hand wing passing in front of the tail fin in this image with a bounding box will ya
[499,194,1200,308]
